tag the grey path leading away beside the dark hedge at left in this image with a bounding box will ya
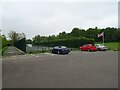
[4,46,24,56]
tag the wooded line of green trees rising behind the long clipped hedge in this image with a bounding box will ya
[33,27,120,46]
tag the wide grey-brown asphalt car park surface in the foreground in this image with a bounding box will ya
[2,51,118,88]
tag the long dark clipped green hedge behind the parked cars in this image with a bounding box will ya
[35,38,95,48]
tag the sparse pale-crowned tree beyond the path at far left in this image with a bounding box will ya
[8,31,25,45]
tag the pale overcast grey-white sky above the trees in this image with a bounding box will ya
[0,0,118,38]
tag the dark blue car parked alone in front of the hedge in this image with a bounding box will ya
[52,46,70,54]
